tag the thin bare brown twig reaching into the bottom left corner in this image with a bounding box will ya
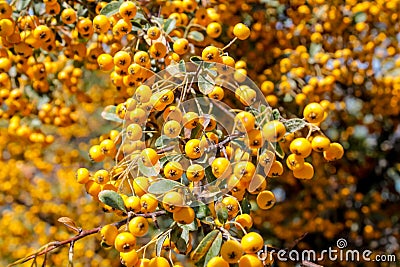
[8,210,166,267]
